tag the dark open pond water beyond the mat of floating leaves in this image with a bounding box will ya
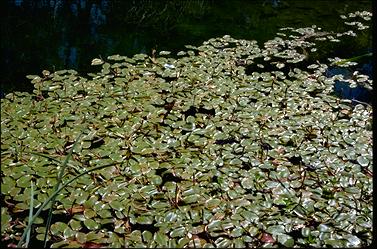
[0,0,372,96]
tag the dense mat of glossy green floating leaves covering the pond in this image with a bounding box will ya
[1,12,373,247]
